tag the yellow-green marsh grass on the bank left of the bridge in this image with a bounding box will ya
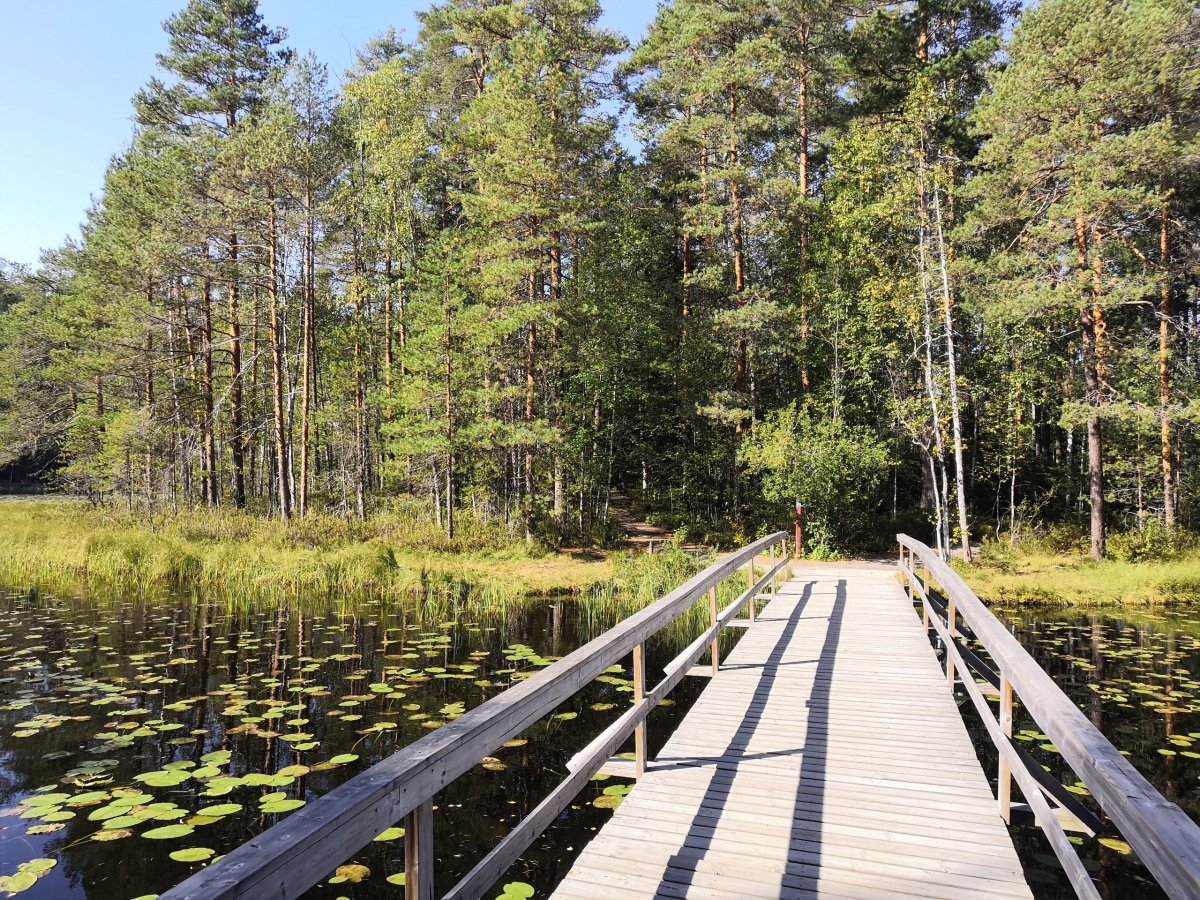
[0,499,613,600]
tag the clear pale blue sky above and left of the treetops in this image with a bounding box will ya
[0,0,655,270]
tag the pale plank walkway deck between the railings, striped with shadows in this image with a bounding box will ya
[554,564,1031,900]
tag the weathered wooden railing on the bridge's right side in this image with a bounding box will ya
[896,534,1200,900]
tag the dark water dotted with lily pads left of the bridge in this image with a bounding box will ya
[0,592,707,900]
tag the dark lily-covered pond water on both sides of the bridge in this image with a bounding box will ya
[0,580,1200,900]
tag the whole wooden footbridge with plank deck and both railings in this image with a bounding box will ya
[162,533,1200,900]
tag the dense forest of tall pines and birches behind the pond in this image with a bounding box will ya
[0,0,1200,558]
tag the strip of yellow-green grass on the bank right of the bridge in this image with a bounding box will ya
[954,544,1200,607]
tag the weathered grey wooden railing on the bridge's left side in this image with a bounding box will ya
[162,532,787,900]
